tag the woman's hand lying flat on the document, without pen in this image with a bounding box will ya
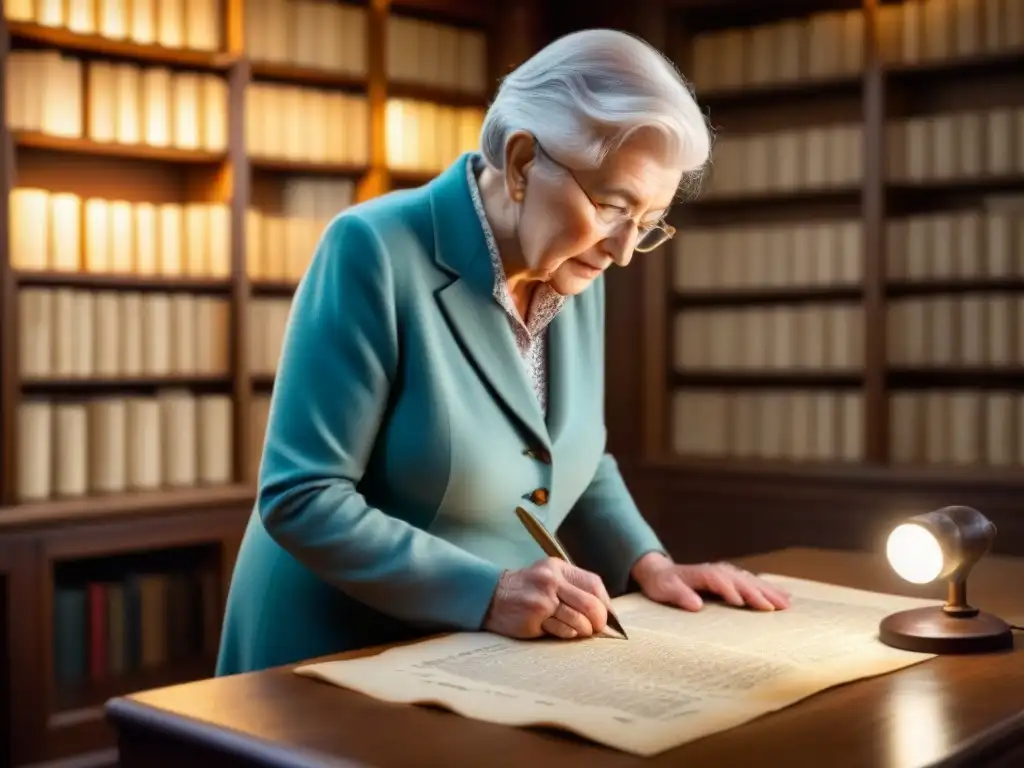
[632,552,790,610]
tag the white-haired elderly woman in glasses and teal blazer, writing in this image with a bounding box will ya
[218,30,787,675]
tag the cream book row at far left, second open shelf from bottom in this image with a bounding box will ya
[17,288,230,381]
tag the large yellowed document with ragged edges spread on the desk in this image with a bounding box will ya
[296,574,941,756]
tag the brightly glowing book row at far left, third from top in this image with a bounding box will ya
[8,187,231,278]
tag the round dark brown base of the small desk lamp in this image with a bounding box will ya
[879,605,1014,653]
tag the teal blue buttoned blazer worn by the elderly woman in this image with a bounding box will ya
[217,156,664,675]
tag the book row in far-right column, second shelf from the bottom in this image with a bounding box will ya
[886,293,1024,368]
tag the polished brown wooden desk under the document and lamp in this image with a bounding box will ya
[108,550,1024,768]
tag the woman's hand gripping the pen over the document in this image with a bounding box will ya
[483,557,611,640]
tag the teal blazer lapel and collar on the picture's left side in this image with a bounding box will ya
[430,155,551,451]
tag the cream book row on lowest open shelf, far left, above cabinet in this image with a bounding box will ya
[16,389,234,502]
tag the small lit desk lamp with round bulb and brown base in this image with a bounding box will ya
[879,507,1014,653]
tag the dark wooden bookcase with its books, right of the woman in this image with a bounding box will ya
[587,0,1024,559]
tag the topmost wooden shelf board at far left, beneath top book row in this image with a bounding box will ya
[7,20,237,71]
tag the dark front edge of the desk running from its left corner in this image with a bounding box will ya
[103,696,370,768]
